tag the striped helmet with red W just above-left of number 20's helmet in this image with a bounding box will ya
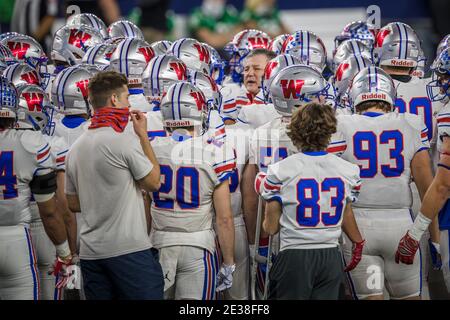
[142,54,188,97]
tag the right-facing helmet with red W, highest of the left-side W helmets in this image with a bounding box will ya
[50,25,103,66]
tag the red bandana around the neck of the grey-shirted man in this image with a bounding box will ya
[89,108,130,132]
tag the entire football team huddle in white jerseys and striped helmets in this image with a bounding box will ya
[0,14,450,300]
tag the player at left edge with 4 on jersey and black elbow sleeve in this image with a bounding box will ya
[0,77,72,300]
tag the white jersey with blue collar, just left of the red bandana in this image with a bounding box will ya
[53,116,90,148]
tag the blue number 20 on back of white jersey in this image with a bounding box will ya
[153,165,200,209]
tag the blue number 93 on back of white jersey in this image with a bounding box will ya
[353,130,405,178]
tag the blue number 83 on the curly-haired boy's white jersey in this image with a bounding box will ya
[297,178,345,227]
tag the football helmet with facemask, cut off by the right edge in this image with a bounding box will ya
[427,48,450,103]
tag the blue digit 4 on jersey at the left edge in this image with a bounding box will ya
[0,151,17,200]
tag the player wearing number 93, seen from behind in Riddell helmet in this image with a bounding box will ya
[328,66,432,300]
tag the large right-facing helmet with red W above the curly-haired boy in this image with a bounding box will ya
[269,65,330,117]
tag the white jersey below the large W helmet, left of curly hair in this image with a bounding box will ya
[249,116,298,172]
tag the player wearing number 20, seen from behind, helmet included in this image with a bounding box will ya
[150,82,236,300]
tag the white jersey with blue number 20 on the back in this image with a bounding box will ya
[150,135,236,252]
